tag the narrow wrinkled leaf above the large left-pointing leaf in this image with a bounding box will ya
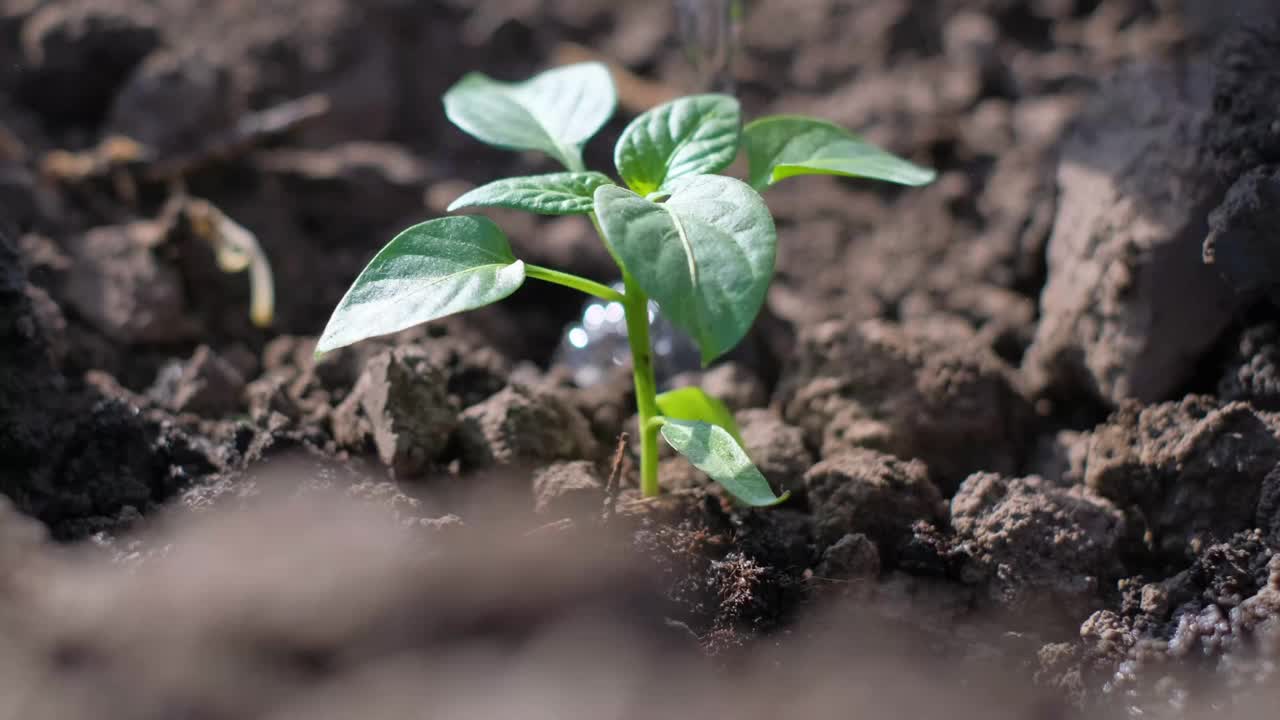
[449,173,612,215]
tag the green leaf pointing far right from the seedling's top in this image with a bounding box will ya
[742,115,937,190]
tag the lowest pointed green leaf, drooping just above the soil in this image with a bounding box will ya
[662,418,791,507]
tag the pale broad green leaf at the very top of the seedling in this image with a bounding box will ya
[444,63,617,170]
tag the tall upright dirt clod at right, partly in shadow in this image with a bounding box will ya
[1024,63,1240,406]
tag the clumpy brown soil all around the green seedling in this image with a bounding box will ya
[0,0,1280,719]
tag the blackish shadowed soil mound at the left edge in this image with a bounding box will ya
[0,226,214,538]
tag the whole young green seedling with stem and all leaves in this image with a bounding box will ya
[309,63,934,506]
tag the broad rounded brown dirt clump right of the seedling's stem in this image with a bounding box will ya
[777,322,1030,492]
